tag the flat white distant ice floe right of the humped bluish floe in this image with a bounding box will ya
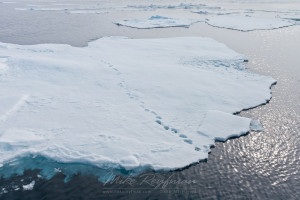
[206,15,295,31]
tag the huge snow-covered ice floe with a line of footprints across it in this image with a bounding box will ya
[0,37,275,181]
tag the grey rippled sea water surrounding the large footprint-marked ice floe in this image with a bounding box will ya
[0,0,300,200]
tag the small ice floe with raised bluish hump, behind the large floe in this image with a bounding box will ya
[115,15,200,29]
